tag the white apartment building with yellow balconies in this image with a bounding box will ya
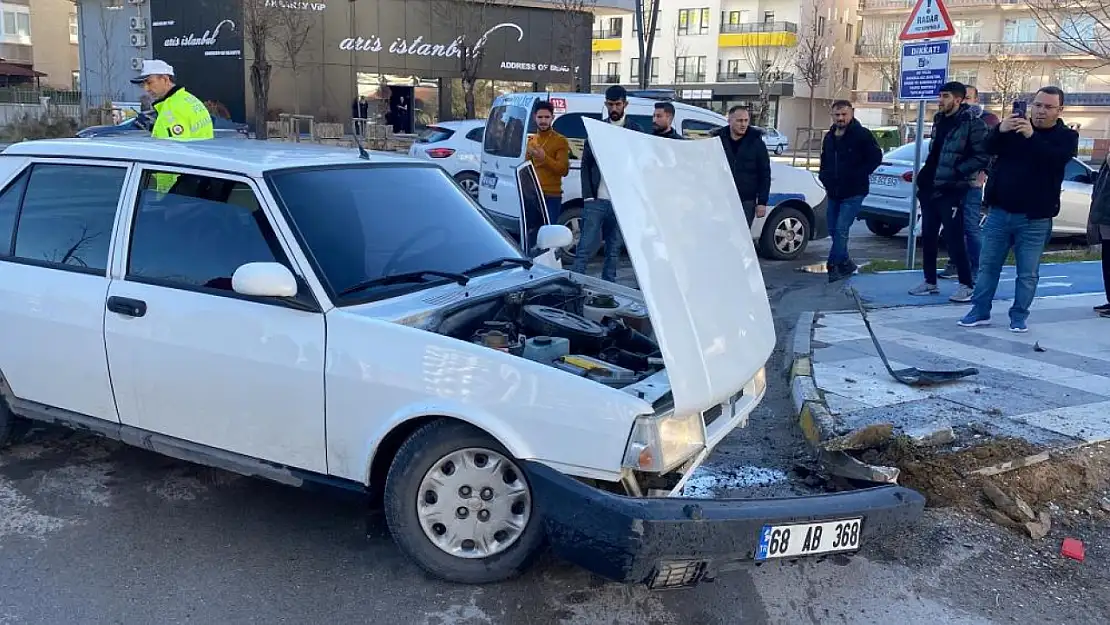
[591,0,858,142]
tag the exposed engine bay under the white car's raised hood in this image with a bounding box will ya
[434,280,663,389]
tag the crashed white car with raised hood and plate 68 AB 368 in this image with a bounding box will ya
[0,135,924,587]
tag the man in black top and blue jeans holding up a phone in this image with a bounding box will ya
[959,87,1079,332]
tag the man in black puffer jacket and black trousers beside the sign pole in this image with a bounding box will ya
[909,82,990,302]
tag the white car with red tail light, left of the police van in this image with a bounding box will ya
[408,120,485,199]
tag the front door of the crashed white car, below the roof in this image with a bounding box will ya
[104,167,327,473]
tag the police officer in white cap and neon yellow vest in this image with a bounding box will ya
[131,60,213,141]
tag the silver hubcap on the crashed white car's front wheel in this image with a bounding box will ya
[416,447,532,558]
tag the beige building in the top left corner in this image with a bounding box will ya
[0,0,80,89]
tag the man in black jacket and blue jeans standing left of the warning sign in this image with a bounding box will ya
[818,100,882,282]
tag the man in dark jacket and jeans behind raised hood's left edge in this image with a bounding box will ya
[571,84,644,282]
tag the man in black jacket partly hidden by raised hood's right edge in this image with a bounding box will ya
[714,104,770,228]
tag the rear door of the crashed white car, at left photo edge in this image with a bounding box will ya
[0,158,130,423]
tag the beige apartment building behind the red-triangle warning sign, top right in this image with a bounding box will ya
[854,0,1110,138]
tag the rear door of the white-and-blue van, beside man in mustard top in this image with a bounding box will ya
[478,93,541,219]
